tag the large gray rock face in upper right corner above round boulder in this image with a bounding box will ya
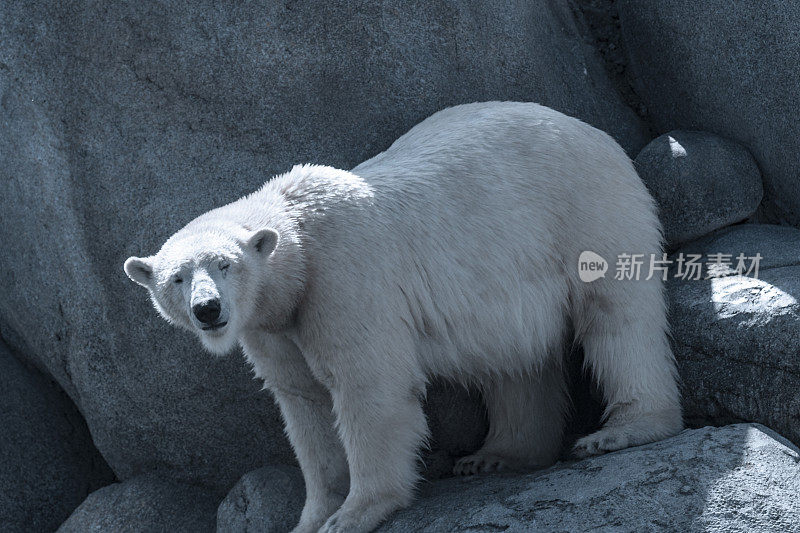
[617,0,800,225]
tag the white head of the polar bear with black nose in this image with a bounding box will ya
[124,222,302,354]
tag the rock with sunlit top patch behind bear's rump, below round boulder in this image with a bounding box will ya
[667,224,800,443]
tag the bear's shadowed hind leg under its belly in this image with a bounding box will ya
[453,361,568,475]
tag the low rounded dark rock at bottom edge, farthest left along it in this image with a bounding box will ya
[58,474,219,533]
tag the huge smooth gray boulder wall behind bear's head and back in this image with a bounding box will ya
[0,0,646,492]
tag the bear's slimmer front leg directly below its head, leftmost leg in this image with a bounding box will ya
[242,333,348,533]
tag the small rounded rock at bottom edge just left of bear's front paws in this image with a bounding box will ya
[217,466,306,533]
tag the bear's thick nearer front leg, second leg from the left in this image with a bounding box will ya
[320,354,428,533]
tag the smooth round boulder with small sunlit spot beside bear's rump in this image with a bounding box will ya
[635,130,764,245]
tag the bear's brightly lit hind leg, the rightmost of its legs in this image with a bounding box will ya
[574,281,683,457]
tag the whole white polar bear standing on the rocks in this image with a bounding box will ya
[125,102,682,532]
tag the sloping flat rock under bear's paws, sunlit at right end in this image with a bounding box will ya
[379,424,800,532]
